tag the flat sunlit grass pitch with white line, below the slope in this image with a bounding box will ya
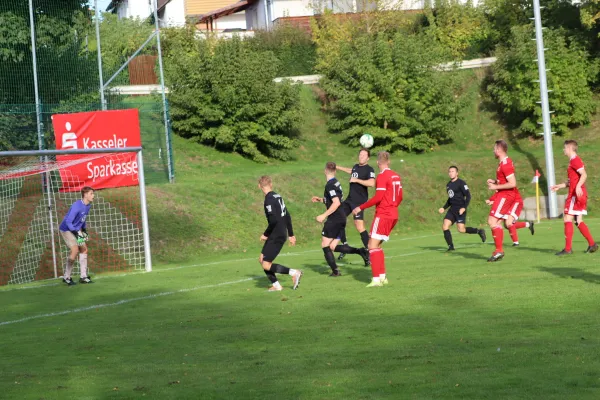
[0,220,600,399]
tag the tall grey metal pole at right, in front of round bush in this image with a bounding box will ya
[533,0,558,218]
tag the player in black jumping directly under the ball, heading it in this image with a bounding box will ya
[336,148,375,260]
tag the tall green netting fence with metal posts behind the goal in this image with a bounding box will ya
[0,0,175,183]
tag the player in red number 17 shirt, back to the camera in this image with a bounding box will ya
[352,151,402,287]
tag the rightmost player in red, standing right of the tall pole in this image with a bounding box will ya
[551,140,598,256]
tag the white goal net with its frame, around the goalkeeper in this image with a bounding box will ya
[0,149,150,285]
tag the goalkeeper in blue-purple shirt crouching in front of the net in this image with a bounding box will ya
[59,186,94,286]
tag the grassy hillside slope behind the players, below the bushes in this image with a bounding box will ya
[148,71,600,263]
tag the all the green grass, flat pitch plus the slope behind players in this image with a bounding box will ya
[0,72,600,399]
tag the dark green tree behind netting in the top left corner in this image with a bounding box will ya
[0,0,97,104]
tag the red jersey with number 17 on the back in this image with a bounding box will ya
[360,168,402,219]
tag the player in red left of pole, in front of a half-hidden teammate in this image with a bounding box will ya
[487,140,517,262]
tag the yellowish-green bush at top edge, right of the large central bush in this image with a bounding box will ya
[425,0,493,59]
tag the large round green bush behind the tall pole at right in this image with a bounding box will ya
[487,25,599,134]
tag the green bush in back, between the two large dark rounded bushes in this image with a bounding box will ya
[246,24,316,76]
